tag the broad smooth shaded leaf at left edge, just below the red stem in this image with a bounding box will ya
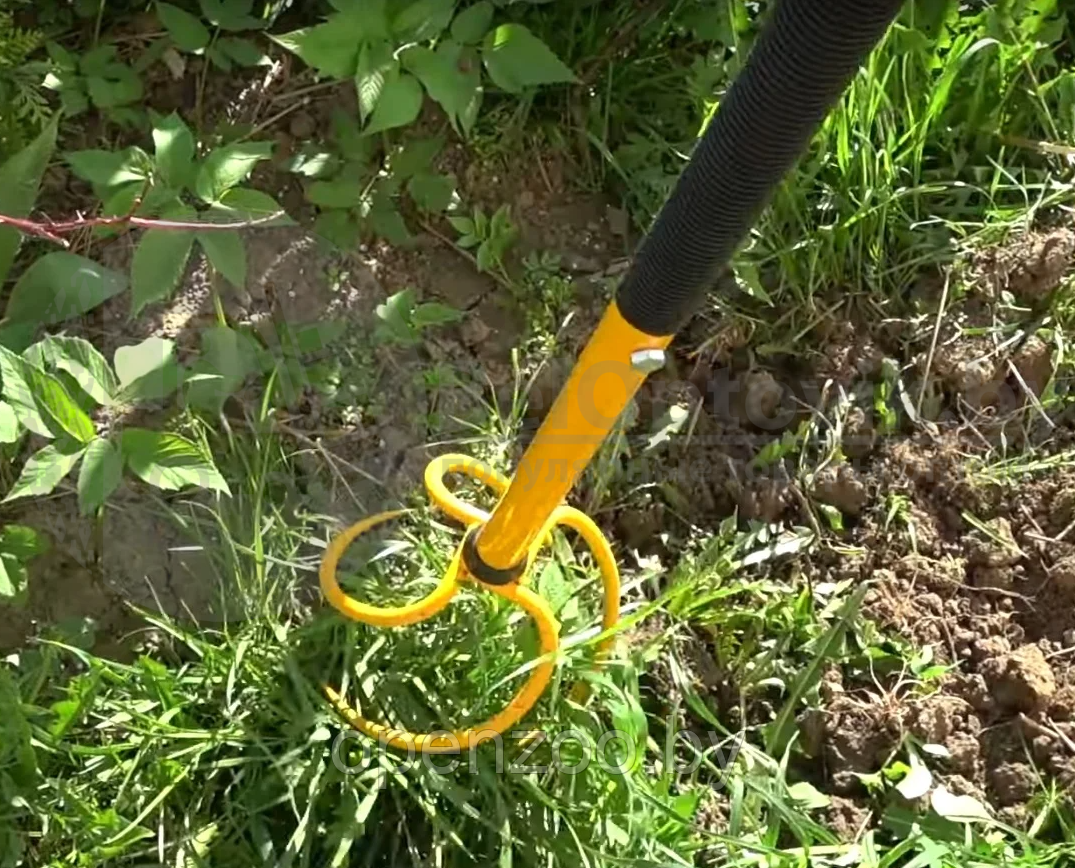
[4,258,127,325]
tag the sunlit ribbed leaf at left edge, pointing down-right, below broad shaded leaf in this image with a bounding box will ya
[0,346,96,443]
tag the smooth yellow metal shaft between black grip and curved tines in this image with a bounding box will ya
[477,301,673,570]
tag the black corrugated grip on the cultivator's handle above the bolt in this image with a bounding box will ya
[616,0,903,335]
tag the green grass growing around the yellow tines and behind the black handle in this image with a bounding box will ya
[6,0,1075,868]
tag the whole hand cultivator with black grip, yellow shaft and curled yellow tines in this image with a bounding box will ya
[320,0,901,752]
